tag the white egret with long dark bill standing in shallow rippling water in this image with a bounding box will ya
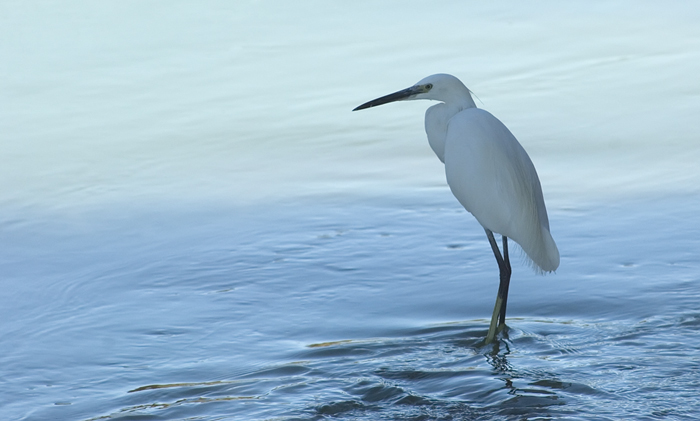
[353,74,559,343]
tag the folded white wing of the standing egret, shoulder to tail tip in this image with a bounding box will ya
[445,108,559,271]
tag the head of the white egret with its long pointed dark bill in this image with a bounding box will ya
[353,73,474,111]
